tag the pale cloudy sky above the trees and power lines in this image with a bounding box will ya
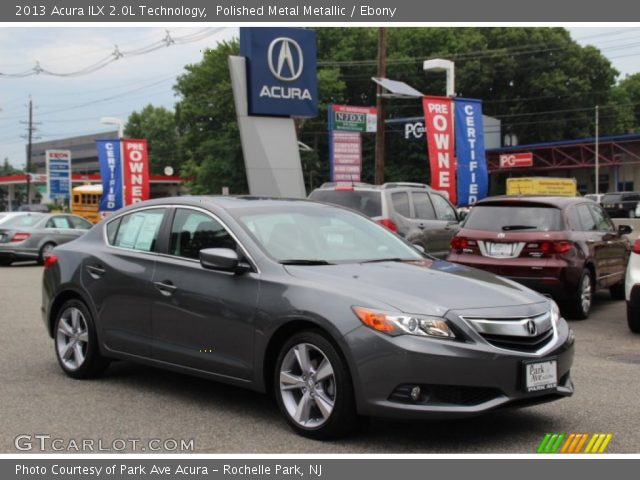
[0,27,640,168]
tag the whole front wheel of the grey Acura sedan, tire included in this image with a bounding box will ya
[274,330,357,440]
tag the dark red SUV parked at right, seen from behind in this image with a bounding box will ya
[447,196,632,319]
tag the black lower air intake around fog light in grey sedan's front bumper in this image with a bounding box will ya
[389,384,502,406]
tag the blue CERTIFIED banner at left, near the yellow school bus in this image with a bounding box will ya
[96,140,123,212]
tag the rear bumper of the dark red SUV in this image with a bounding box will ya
[447,253,582,300]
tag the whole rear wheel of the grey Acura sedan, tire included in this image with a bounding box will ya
[53,300,109,378]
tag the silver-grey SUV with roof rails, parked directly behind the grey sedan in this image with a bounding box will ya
[309,182,460,258]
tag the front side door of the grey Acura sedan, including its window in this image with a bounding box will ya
[151,208,259,379]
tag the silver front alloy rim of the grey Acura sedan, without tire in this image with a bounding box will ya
[279,343,336,428]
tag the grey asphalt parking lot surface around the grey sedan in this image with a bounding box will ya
[0,263,640,454]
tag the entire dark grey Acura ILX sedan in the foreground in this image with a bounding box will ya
[42,197,574,438]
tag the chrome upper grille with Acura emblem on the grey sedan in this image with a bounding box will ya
[462,312,555,353]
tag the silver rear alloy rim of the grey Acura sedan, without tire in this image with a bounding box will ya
[56,307,89,371]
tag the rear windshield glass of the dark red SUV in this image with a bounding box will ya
[464,204,564,232]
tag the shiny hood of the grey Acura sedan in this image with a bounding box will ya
[286,259,547,316]
